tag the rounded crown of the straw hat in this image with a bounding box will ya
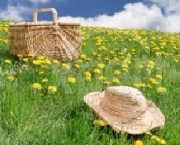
[102,86,147,113]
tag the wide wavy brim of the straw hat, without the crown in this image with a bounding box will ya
[84,91,165,134]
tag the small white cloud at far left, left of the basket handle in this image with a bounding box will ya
[0,5,32,21]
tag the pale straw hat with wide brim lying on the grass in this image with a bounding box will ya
[84,86,165,134]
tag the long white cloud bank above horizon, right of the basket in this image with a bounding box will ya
[59,3,180,32]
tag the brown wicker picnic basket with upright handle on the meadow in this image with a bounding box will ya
[9,8,82,61]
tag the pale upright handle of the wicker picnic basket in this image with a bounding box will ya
[33,8,58,24]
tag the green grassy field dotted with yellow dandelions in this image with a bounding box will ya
[0,21,180,145]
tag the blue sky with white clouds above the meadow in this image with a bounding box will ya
[0,0,180,32]
